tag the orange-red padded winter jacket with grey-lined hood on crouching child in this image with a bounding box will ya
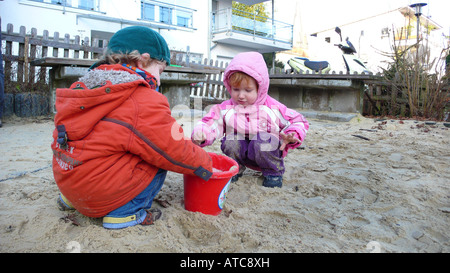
[51,65,212,217]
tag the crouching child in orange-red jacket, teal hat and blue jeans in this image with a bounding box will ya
[51,26,212,229]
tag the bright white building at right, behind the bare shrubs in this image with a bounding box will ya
[298,7,449,73]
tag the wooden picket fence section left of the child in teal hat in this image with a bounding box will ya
[2,24,103,117]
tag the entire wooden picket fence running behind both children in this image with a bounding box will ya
[2,21,442,116]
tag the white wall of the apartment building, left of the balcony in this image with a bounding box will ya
[0,0,210,57]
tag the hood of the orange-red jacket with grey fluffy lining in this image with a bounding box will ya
[55,64,147,140]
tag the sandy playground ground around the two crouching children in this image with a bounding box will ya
[0,111,450,253]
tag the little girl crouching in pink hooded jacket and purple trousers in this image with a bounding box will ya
[192,52,309,187]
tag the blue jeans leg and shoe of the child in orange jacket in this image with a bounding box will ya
[103,169,167,229]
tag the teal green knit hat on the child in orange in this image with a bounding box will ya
[107,26,170,65]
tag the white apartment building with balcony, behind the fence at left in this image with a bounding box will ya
[0,0,293,62]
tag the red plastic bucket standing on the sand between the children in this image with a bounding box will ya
[183,153,239,215]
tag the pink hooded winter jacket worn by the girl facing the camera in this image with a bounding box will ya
[192,52,309,157]
